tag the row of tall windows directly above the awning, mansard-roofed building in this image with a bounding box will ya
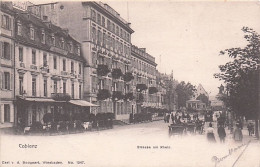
[19,75,82,99]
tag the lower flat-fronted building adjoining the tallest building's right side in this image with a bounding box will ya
[131,45,157,112]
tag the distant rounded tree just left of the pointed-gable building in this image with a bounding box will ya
[176,81,196,107]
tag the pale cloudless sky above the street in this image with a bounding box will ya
[103,0,260,96]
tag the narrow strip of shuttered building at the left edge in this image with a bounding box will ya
[0,2,15,128]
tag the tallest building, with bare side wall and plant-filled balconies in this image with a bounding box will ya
[29,2,134,119]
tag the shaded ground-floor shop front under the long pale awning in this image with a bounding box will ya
[17,97,98,132]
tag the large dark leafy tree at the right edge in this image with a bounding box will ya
[214,27,260,140]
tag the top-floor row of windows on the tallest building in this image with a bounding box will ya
[91,10,130,42]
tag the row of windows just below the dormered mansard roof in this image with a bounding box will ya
[19,47,82,74]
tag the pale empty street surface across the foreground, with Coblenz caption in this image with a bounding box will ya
[1,121,259,167]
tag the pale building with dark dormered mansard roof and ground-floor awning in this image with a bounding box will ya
[14,9,84,126]
